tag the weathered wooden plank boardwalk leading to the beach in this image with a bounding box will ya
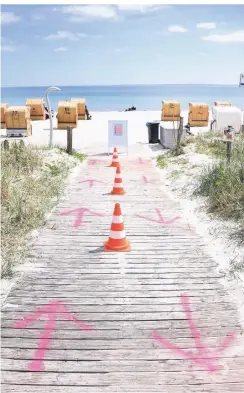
[2,151,244,393]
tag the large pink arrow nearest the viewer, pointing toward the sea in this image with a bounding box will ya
[13,300,92,371]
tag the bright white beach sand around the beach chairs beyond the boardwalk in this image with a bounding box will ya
[2,111,211,153]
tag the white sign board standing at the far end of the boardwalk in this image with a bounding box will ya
[108,120,128,153]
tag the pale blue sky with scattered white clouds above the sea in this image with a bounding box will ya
[1,4,244,86]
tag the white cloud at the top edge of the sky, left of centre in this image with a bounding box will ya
[61,5,118,22]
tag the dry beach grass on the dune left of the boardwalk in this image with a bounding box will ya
[1,142,85,277]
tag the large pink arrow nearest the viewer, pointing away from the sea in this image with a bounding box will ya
[152,294,235,372]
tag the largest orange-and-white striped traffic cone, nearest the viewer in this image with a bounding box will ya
[104,203,131,251]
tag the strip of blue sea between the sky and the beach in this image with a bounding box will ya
[1,84,244,111]
